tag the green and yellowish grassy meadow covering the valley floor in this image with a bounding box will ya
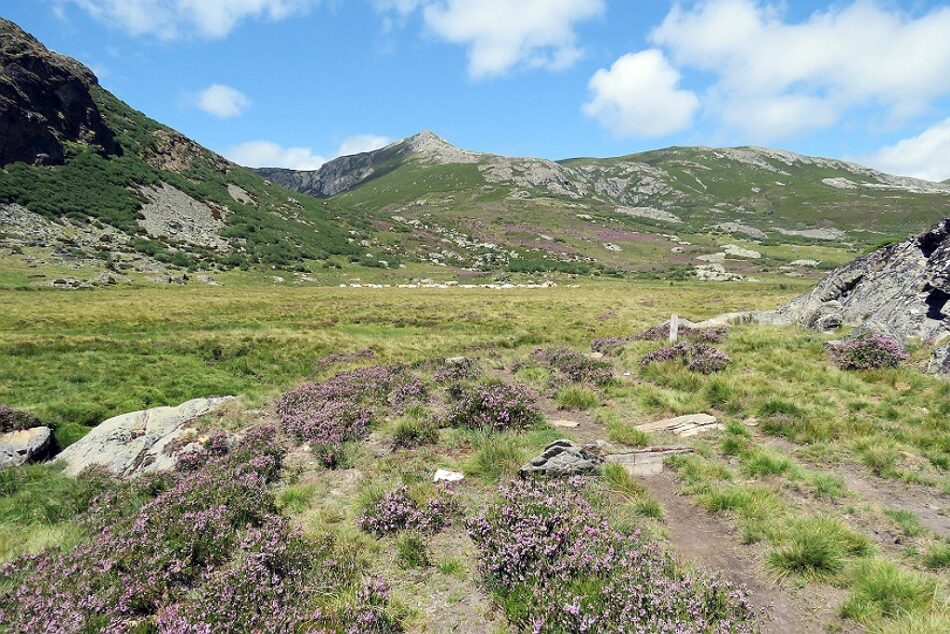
[0,280,950,634]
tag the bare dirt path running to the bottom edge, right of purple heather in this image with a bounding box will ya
[638,471,860,634]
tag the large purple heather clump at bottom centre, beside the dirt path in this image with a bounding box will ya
[468,479,757,633]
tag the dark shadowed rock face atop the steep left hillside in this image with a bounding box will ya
[0,18,120,167]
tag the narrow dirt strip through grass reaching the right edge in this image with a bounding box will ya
[768,434,950,537]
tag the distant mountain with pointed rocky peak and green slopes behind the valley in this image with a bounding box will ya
[258,131,950,277]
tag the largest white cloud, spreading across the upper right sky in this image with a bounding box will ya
[650,0,950,138]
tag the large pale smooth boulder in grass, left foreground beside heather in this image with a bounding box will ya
[56,396,234,476]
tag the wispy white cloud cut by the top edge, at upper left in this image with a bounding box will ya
[69,0,318,40]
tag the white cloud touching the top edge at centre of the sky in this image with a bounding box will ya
[376,0,604,79]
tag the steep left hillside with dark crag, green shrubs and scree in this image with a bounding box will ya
[0,19,363,284]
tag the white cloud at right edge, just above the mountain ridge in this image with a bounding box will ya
[864,117,950,181]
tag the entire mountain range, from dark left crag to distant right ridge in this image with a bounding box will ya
[0,19,950,285]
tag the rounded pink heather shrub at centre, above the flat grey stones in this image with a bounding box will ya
[446,384,541,431]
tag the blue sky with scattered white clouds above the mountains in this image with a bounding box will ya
[0,0,950,180]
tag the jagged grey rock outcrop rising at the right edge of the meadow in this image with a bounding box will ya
[776,218,950,345]
